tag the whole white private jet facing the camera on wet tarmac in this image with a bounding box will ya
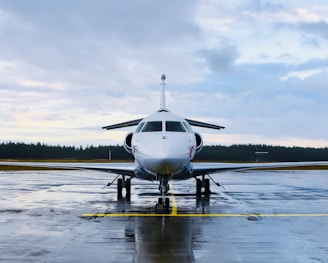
[0,74,328,211]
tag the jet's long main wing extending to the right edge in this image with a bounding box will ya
[193,162,328,176]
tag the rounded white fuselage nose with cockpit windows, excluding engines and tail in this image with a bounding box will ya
[131,109,197,182]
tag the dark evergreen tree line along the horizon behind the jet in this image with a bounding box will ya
[0,142,328,162]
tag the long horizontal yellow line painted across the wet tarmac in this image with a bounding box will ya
[82,214,328,217]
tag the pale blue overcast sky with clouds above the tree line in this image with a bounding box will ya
[0,0,328,147]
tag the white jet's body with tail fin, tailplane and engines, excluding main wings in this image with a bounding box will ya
[102,74,224,183]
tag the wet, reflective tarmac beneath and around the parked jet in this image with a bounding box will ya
[0,171,328,262]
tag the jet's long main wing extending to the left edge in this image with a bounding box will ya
[0,162,135,177]
